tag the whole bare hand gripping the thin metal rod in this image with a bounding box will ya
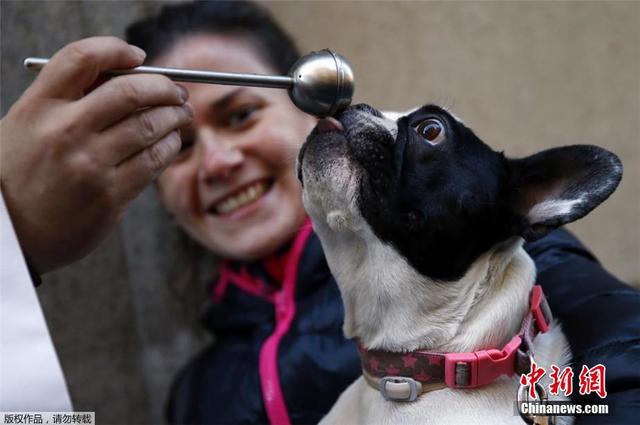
[0,37,193,273]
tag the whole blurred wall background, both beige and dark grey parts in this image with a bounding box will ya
[0,0,640,424]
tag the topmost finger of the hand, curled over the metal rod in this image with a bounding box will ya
[32,37,145,99]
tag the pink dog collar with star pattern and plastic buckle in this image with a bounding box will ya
[358,285,552,401]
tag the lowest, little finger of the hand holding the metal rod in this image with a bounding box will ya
[115,131,181,203]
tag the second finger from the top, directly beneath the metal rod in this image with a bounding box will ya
[76,74,189,131]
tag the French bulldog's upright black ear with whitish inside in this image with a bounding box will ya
[508,145,622,240]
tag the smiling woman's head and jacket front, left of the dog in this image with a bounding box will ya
[122,2,359,424]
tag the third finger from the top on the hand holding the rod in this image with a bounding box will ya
[99,104,193,165]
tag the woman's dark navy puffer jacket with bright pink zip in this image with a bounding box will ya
[168,224,640,425]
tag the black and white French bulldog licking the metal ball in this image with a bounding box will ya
[297,104,622,424]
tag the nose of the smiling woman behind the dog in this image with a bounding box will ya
[199,126,244,182]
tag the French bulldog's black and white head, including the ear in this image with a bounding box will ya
[298,105,622,281]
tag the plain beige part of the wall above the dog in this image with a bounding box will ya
[267,1,640,284]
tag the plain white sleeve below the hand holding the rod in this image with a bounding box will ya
[0,196,72,412]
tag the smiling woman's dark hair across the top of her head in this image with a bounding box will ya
[125,1,300,75]
